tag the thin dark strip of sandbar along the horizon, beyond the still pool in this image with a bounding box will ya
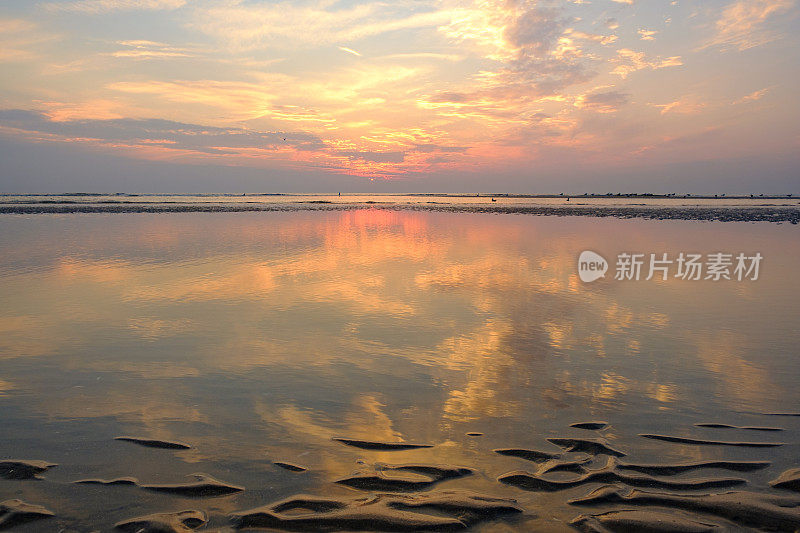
[0,203,800,224]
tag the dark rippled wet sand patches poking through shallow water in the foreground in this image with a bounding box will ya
[0,423,800,533]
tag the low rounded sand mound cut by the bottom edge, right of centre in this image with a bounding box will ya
[570,510,727,533]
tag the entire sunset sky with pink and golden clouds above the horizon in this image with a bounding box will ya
[0,0,800,194]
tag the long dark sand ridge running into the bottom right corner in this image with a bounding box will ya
[569,486,800,532]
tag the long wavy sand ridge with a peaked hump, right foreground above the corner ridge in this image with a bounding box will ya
[497,457,747,492]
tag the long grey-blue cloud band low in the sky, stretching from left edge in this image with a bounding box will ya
[0,109,438,176]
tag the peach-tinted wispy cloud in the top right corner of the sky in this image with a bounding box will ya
[701,0,794,51]
